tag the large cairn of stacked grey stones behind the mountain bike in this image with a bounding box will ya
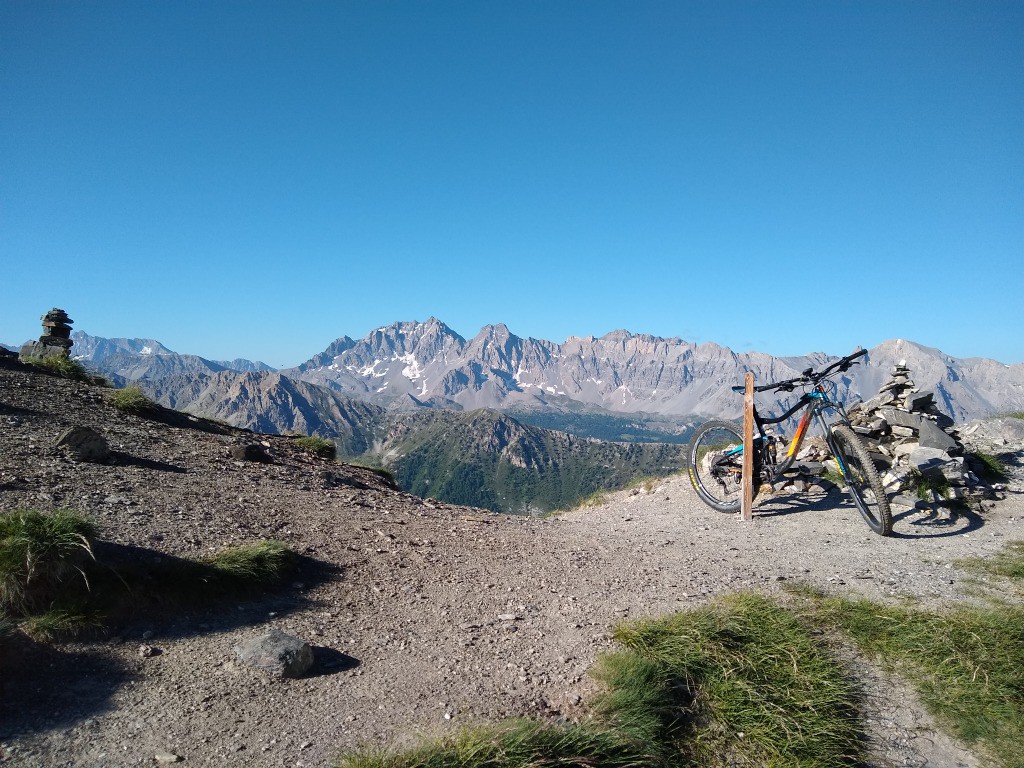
[850,360,998,505]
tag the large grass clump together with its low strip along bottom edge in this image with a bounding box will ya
[337,593,860,768]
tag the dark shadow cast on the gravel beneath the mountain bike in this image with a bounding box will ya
[754,490,985,539]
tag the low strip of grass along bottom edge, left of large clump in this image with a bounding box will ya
[335,720,655,768]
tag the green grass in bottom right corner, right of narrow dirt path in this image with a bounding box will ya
[817,598,1024,768]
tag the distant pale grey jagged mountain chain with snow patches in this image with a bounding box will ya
[284,317,1024,421]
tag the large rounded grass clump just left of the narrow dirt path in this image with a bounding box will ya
[598,593,861,768]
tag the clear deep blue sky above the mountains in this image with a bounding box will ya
[0,0,1024,366]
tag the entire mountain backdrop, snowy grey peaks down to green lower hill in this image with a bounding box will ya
[9,317,1024,511]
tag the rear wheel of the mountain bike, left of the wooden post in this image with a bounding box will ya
[686,421,760,512]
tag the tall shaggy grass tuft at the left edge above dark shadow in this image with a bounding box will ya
[0,509,96,615]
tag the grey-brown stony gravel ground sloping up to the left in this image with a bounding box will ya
[0,364,1024,767]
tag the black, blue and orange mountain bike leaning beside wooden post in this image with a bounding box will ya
[687,349,893,536]
